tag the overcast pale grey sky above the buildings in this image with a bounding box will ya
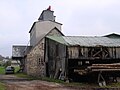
[0,0,120,56]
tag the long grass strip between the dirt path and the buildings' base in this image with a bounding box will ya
[15,73,120,89]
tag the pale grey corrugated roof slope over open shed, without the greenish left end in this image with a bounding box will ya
[63,36,120,47]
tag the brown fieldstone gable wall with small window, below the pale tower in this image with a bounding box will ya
[26,29,62,77]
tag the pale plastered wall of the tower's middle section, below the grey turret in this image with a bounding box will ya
[31,21,61,46]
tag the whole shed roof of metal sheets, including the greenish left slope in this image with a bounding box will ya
[48,36,120,47]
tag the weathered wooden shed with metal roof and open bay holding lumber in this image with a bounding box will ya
[45,34,120,83]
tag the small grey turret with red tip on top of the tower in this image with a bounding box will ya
[38,6,55,21]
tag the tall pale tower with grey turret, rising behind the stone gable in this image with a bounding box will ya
[29,6,62,46]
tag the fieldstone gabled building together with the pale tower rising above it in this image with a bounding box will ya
[25,9,63,77]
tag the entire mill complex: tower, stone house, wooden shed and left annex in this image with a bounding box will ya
[13,7,120,83]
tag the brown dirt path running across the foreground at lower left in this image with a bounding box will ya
[0,75,78,90]
